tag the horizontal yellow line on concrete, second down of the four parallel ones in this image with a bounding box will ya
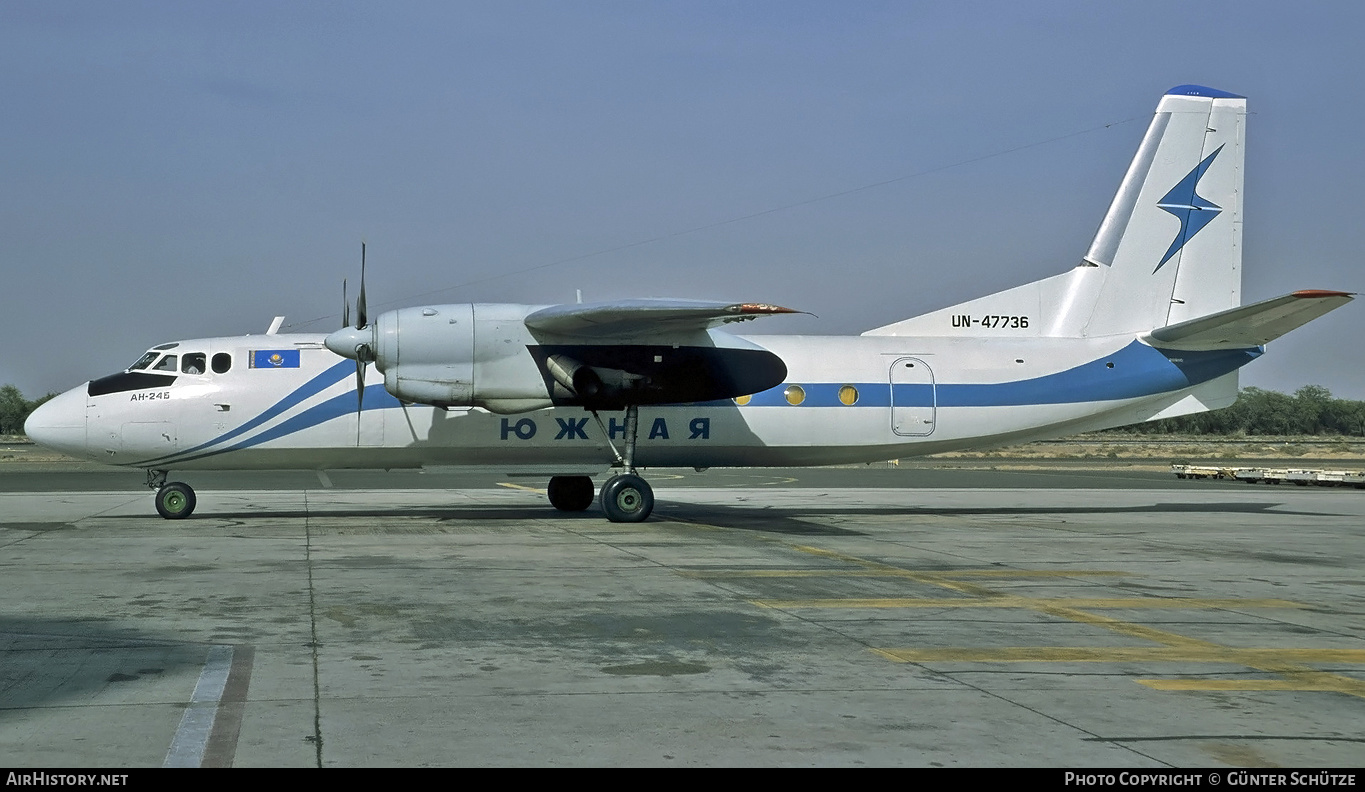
[751,595,1308,609]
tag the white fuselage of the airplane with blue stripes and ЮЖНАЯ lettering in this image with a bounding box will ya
[30,324,1259,472]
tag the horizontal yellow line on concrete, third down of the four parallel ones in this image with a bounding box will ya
[872,646,1365,666]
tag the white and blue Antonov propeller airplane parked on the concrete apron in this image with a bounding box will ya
[25,85,1354,522]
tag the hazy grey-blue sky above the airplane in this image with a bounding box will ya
[0,0,1365,399]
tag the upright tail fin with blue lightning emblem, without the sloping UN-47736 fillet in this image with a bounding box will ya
[1082,85,1246,336]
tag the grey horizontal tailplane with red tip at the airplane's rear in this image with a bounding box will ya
[1143,289,1355,350]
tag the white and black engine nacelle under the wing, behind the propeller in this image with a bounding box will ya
[326,303,786,414]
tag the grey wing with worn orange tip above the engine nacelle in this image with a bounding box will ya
[526,299,803,339]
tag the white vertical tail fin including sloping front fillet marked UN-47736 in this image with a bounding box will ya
[863,85,1246,337]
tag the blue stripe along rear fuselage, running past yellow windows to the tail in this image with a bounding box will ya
[726,341,1261,407]
